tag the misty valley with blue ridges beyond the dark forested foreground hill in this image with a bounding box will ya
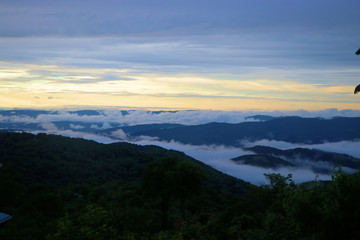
[0,109,360,185]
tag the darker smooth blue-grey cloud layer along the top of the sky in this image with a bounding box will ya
[0,0,359,36]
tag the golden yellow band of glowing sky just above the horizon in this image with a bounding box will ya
[0,62,360,110]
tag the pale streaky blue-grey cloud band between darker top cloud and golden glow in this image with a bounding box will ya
[0,32,359,79]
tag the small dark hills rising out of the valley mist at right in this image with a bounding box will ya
[232,146,360,174]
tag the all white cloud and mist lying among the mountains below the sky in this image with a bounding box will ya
[0,109,360,185]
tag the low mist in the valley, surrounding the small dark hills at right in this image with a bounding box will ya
[26,126,360,185]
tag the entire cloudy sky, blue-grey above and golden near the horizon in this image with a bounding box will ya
[0,0,360,111]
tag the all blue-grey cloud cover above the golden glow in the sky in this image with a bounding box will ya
[0,0,360,93]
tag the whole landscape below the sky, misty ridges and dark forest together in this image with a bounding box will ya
[0,109,360,239]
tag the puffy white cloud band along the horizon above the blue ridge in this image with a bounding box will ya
[0,109,360,125]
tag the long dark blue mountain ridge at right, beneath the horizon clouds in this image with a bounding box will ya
[131,117,360,146]
